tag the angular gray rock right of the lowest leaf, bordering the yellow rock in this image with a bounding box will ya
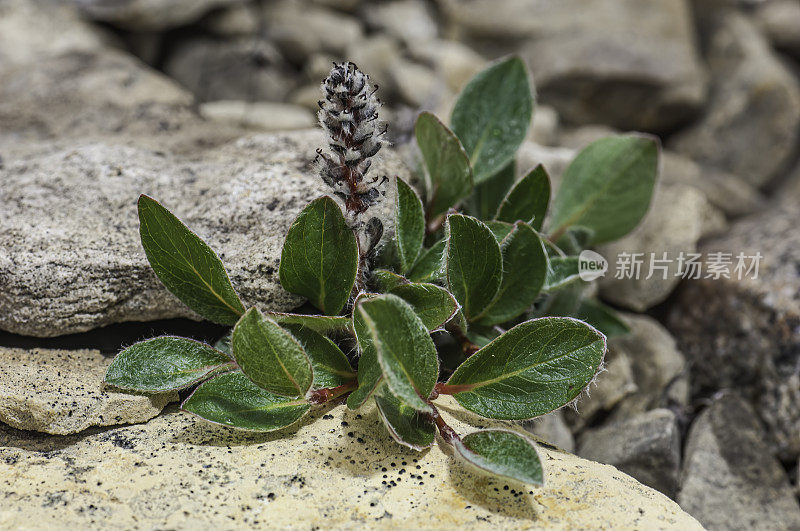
[578,409,681,498]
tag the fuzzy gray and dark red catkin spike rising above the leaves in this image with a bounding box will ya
[317,62,388,215]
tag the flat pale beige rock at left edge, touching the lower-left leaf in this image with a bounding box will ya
[0,347,178,435]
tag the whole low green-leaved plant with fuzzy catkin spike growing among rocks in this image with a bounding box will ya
[106,57,658,484]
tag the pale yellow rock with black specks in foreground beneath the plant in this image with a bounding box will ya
[0,398,701,530]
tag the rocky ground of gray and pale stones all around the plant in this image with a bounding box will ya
[0,0,800,529]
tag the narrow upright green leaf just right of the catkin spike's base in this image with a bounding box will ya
[394,177,425,273]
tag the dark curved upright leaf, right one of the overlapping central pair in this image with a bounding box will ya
[475,222,547,325]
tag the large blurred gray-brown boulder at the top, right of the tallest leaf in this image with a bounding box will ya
[440,0,705,131]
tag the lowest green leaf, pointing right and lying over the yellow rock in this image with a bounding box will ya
[454,429,544,485]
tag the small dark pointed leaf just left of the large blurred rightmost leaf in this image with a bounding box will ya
[496,164,550,230]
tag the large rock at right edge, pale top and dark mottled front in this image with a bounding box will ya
[669,200,800,459]
